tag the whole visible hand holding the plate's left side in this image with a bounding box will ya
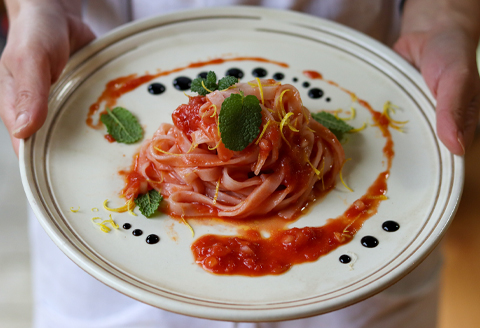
[0,0,95,155]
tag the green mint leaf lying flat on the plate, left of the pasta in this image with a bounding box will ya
[100,107,143,144]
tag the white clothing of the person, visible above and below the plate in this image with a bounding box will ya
[30,0,441,328]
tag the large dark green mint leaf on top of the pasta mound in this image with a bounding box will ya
[218,93,262,151]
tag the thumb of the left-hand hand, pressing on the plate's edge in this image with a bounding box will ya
[2,8,95,139]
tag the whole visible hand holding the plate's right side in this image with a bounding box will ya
[394,0,480,155]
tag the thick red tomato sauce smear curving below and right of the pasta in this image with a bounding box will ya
[191,71,395,276]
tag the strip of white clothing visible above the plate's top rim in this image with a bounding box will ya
[83,0,402,46]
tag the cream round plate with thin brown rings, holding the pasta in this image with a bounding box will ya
[21,7,463,321]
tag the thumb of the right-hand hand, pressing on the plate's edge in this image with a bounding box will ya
[394,30,480,155]
